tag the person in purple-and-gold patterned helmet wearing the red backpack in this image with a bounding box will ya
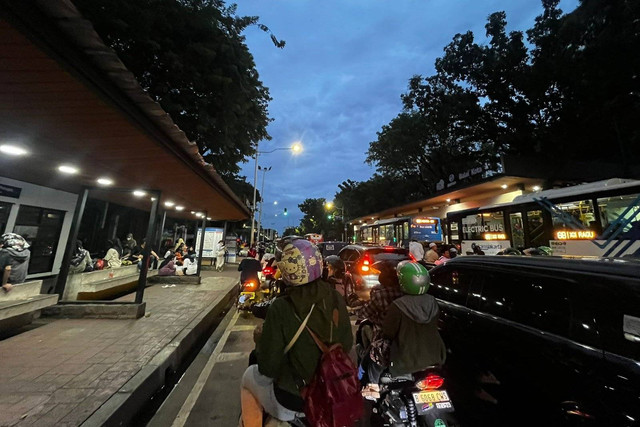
[241,239,353,427]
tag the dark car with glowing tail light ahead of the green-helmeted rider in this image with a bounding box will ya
[338,245,411,300]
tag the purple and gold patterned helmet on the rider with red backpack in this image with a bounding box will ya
[278,239,322,286]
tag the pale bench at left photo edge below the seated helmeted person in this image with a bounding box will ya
[0,280,58,330]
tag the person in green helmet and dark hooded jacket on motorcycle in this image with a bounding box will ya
[360,261,446,391]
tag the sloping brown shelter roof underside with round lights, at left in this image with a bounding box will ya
[0,0,250,220]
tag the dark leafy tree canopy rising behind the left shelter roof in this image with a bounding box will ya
[73,0,284,184]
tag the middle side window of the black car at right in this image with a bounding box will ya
[479,272,571,337]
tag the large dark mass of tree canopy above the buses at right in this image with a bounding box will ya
[336,0,640,218]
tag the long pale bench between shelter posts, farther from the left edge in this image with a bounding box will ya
[62,265,158,301]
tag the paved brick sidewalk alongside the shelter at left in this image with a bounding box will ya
[0,272,237,427]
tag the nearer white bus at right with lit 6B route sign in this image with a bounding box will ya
[447,178,640,257]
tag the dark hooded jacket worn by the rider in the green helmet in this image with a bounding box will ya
[382,294,446,376]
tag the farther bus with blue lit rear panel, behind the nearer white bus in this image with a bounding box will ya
[357,216,442,246]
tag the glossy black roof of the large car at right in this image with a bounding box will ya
[446,255,640,280]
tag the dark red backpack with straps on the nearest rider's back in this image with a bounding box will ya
[285,304,363,427]
